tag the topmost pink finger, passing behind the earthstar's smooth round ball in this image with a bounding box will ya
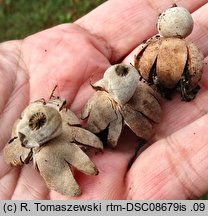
[75,0,207,63]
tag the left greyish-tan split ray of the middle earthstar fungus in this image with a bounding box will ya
[82,91,123,146]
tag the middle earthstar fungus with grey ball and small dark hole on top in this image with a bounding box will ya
[82,64,161,147]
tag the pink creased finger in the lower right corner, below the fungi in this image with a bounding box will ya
[127,114,208,199]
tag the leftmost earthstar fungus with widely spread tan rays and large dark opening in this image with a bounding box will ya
[4,96,103,196]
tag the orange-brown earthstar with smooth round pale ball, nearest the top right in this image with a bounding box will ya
[135,6,204,101]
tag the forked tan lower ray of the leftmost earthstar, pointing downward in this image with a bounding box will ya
[33,134,98,196]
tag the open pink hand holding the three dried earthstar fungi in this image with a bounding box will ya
[0,0,208,199]
